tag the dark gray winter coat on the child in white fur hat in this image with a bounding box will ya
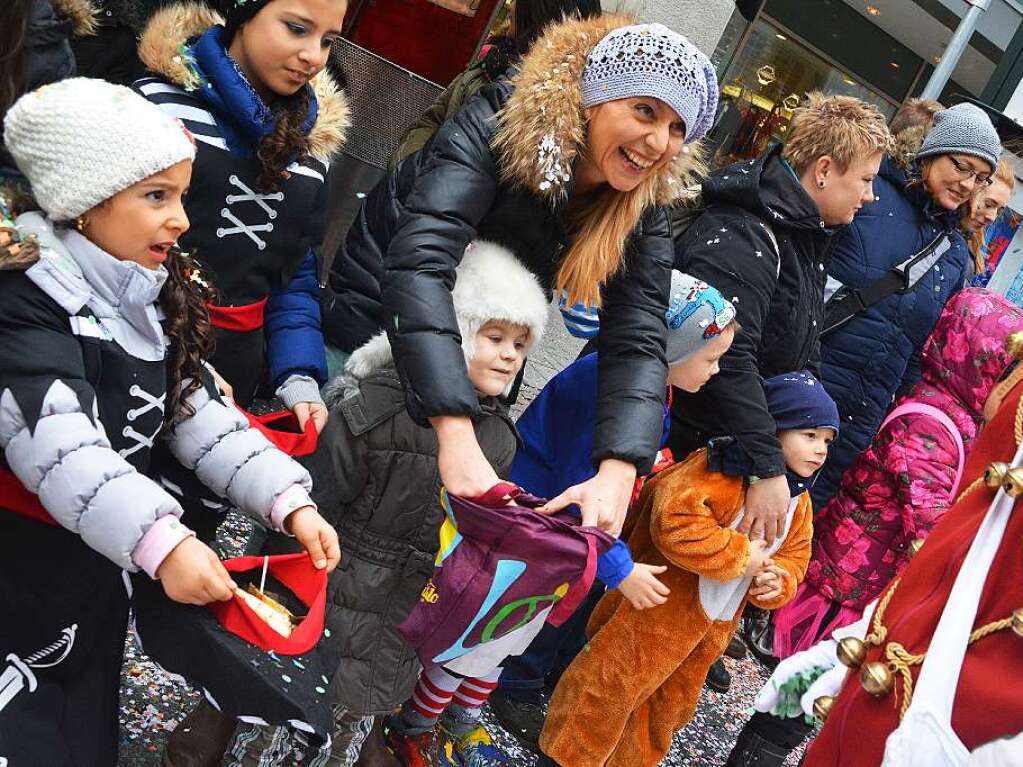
[305,359,518,715]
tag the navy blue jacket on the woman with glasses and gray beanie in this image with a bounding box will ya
[812,157,969,508]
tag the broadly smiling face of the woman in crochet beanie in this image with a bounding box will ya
[575,96,685,192]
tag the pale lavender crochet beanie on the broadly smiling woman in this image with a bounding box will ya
[582,24,718,143]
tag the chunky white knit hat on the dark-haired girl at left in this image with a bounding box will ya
[3,78,195,221]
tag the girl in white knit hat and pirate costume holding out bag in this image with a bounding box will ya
[0,79,339,765]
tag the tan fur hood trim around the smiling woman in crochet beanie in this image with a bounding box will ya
[493,13,707,207]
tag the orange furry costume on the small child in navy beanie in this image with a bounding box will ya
[540,450,812,767]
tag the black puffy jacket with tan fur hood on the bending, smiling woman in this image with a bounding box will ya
[323,17,692,472]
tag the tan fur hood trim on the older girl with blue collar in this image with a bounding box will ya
[138,2,352,161]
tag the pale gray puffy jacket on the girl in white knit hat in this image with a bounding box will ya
[0,214,312,571]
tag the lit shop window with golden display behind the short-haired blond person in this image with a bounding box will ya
[710,17,898,165]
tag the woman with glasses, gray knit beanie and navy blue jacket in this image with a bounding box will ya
[813,103,1002,517]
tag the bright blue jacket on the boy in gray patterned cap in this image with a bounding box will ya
[508,354,669,588]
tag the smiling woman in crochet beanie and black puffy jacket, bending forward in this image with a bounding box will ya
[325,15,717,534]
